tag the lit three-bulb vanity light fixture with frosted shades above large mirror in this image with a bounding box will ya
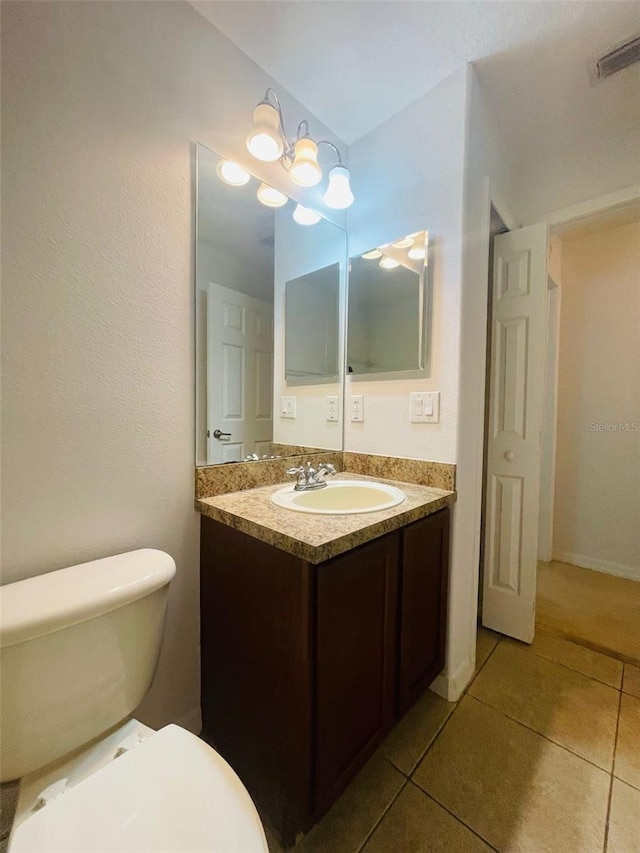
[247,89,354,210]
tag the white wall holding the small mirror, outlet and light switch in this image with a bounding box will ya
[345,68,466,462]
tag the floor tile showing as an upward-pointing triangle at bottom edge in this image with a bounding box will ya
[362,782,491,853]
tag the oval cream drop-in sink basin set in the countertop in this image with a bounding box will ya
[271,480,407,515]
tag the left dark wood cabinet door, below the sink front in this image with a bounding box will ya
[315,533,399,814]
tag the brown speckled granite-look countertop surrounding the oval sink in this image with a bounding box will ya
[196,473,456,563]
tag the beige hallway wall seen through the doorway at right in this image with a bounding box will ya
[553,224,640,580]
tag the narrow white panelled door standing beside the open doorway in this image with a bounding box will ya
[482,224,547,643]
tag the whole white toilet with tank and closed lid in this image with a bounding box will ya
[0,550,268,853]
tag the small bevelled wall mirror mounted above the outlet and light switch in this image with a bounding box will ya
[347,231,429,378]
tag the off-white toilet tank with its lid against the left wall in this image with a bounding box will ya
[0,549,175,782]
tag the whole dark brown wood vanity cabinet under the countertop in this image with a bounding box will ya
[200,509,449,844]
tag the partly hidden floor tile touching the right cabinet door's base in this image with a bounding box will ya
[379,690,455,776]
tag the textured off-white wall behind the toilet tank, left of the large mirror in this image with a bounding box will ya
[2,2,344,725]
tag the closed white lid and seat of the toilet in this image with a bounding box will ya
[9,725,268,853]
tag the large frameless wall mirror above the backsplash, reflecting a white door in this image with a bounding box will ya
[195,145,347,465]
